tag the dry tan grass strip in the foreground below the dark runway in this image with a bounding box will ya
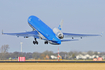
[0,63,105,70]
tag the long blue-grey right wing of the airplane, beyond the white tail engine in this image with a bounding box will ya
[63,33,101,38]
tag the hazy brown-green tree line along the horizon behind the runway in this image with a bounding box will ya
[0,45,105,60]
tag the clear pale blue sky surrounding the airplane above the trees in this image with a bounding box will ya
[0,0,105,52]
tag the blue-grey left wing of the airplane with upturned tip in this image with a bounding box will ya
[2,31,39,38]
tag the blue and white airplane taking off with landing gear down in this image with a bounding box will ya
[2,15,101,45]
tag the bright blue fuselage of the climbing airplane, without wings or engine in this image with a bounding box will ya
[28,16,61,44]
